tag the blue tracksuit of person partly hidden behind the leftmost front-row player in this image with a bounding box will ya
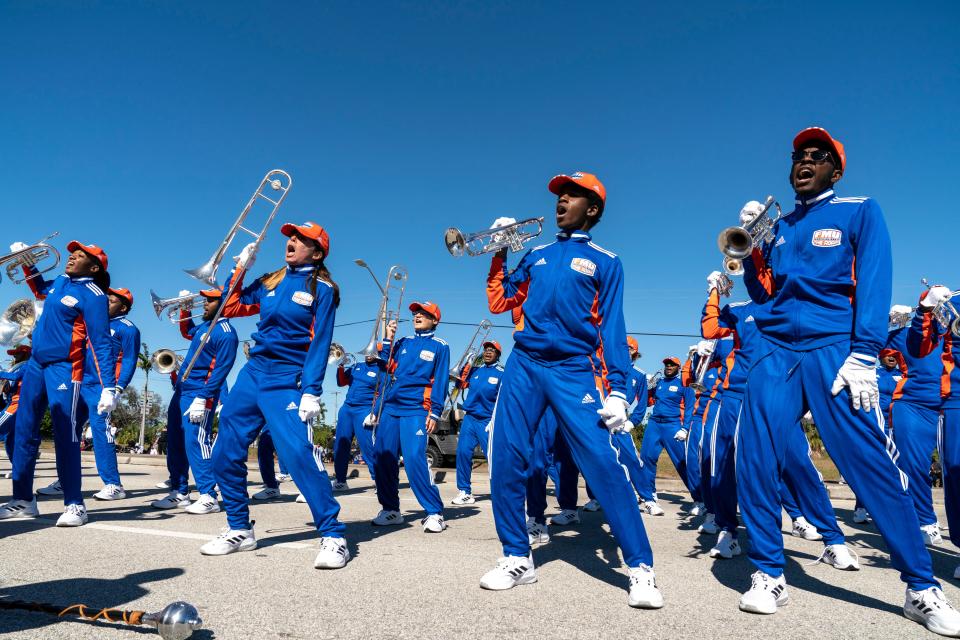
[80,316,140,485]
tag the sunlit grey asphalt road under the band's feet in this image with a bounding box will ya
[0,460,960,640]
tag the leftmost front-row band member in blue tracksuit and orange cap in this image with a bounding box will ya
[0,241,117,527]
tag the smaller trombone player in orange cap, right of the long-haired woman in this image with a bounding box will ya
[367,302,450,533]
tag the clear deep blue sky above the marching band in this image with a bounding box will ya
[0,1,960,412]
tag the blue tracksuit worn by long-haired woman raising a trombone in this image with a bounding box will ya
[213,266,344,538]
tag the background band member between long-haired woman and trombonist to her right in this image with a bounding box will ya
[333,356,385,491]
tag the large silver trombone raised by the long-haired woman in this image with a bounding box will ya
[183,169,293,379]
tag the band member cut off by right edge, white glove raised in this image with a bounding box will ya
[908,285,960,579]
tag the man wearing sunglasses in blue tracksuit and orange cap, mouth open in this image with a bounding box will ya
[736,127,960,636]
